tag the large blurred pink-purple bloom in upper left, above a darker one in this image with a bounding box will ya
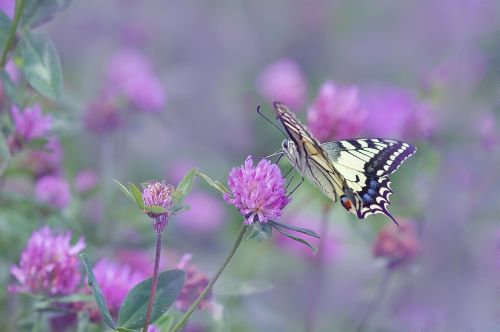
[107,49,166,112]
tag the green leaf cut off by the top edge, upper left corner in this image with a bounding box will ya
[21,0,71,28]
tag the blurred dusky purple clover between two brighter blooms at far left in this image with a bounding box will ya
[26,137,63,178]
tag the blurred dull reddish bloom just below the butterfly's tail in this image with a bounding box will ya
[373,221,420,267]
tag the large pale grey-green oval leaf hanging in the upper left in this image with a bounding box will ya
[16,31,62,100]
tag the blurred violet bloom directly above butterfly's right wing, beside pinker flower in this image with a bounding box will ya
[364,88,435,139]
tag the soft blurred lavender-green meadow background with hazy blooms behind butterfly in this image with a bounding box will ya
[0,0,500,331]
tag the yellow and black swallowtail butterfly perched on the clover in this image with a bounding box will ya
[274,102,417,224]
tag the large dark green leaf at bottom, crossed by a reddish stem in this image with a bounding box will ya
[118,270,186,329]
